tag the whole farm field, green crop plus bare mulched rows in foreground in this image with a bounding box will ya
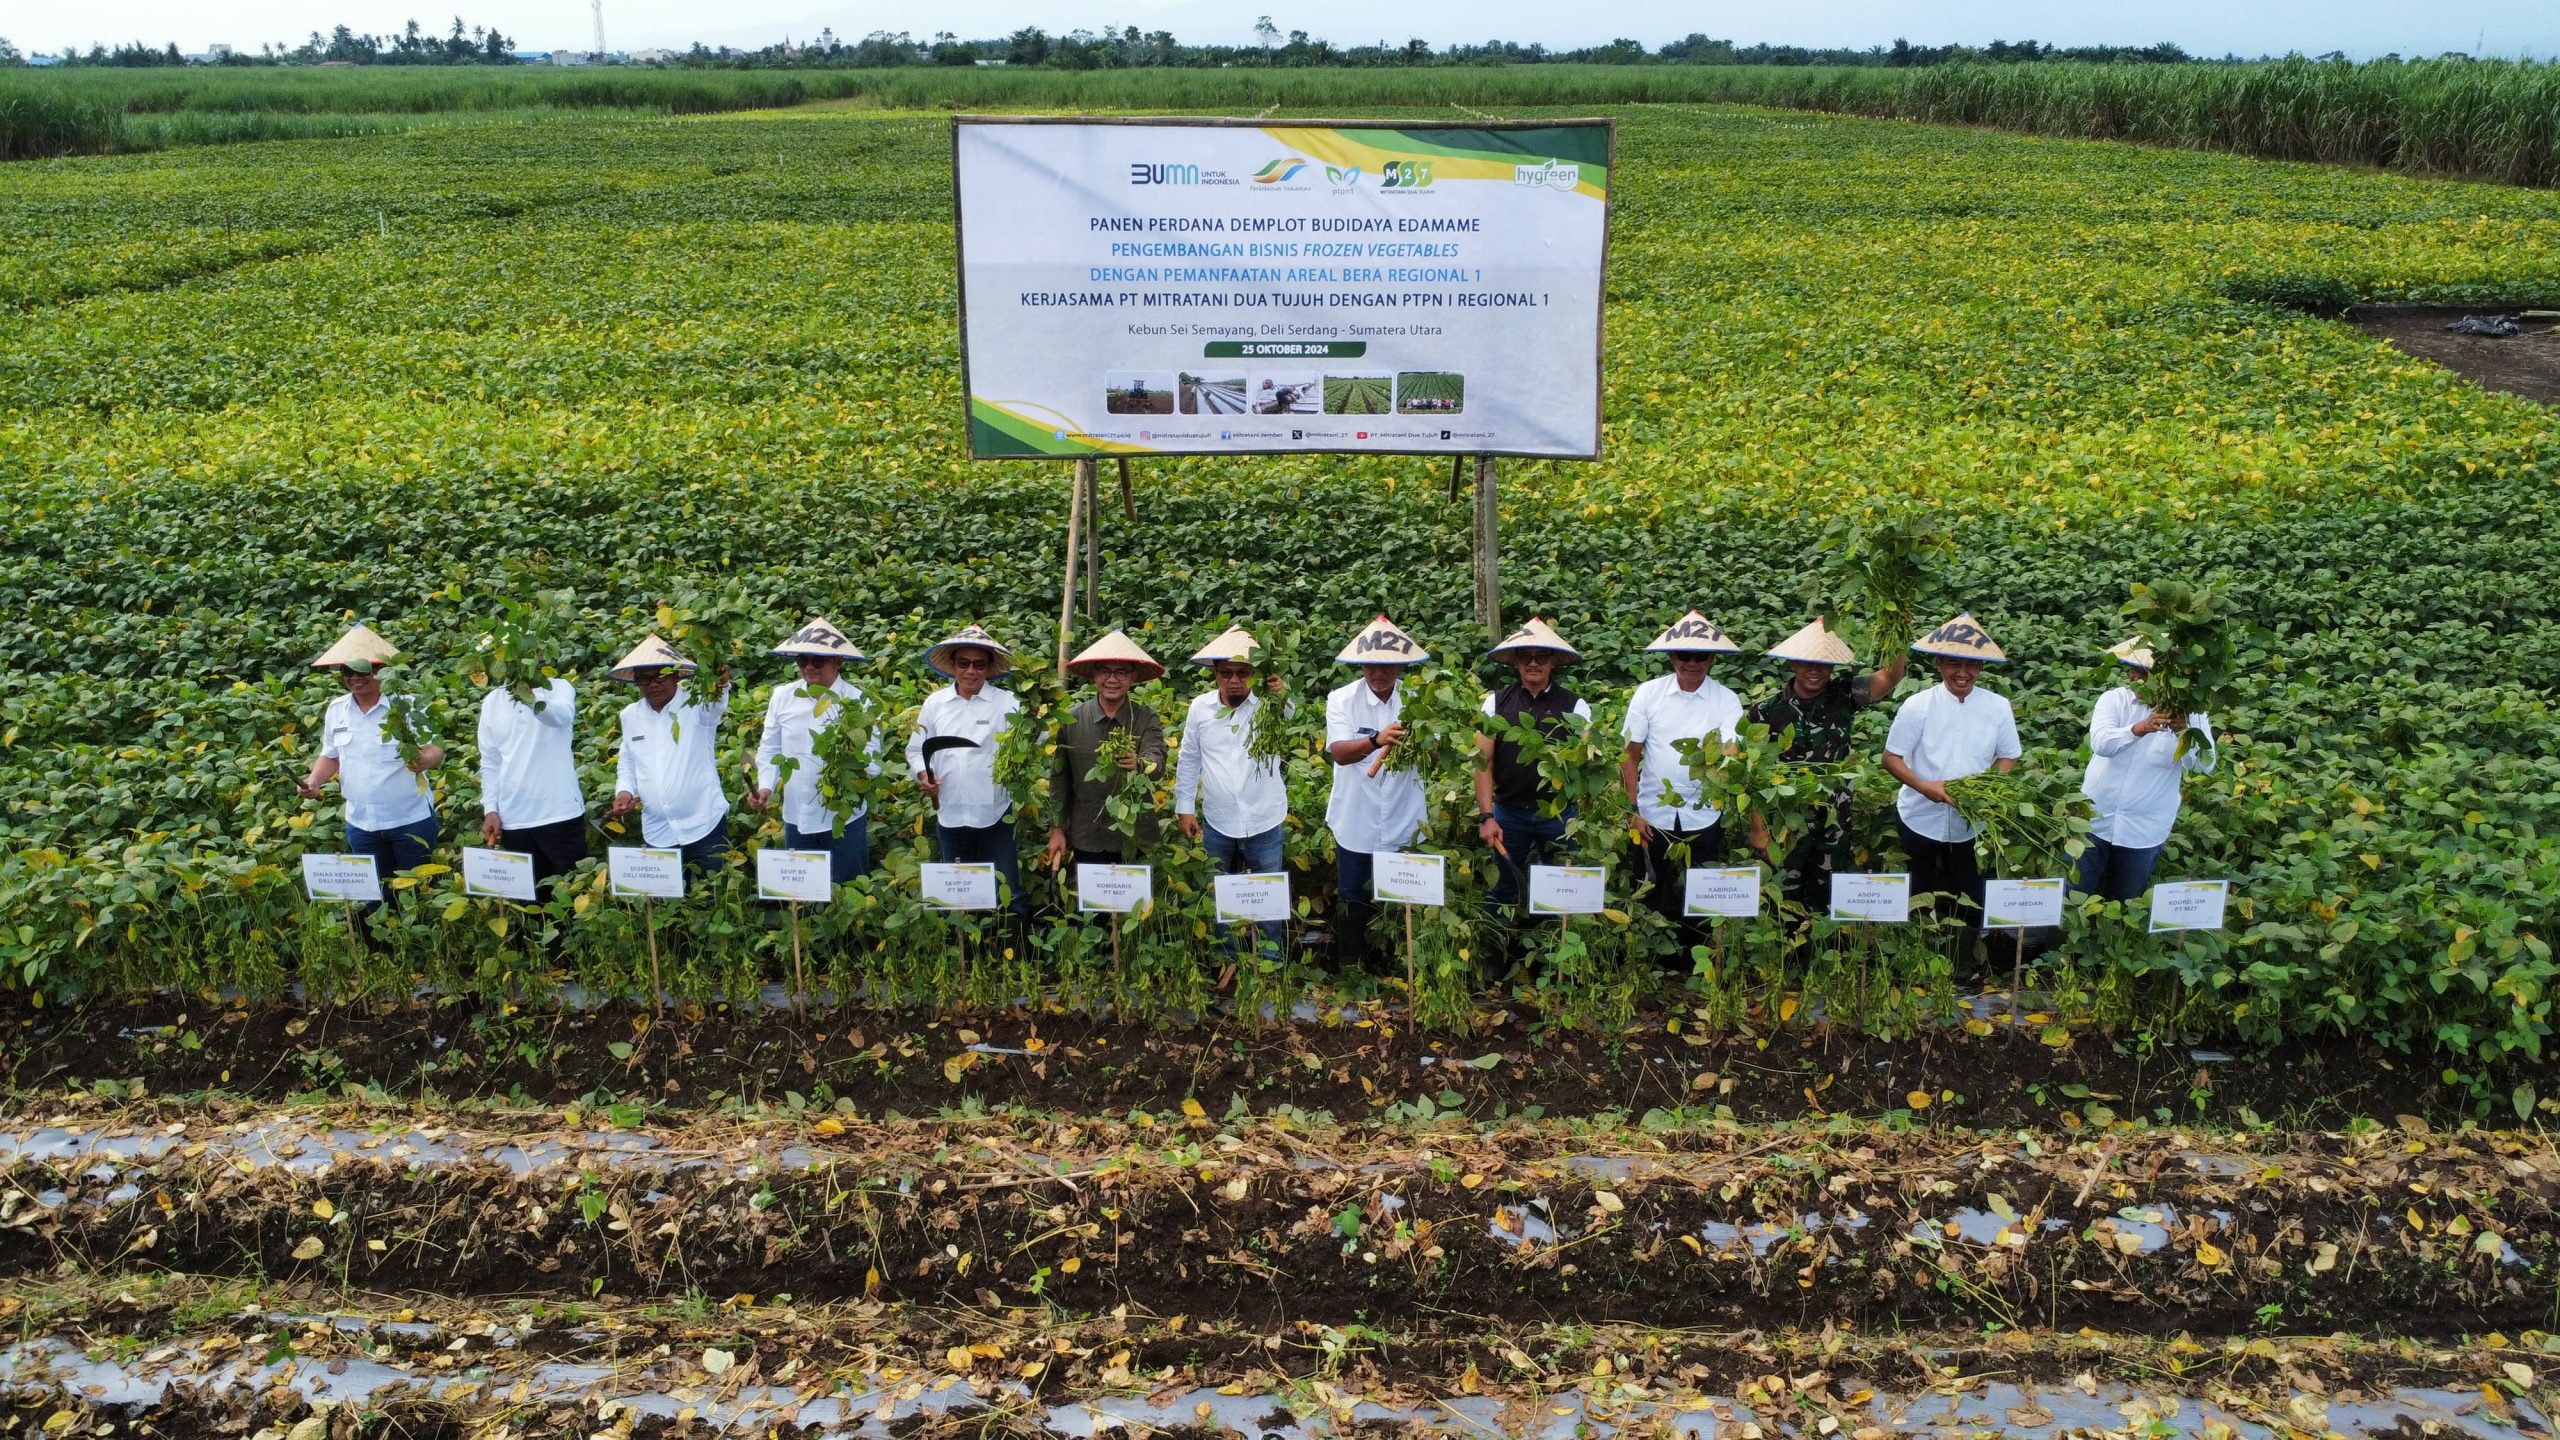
[0,105,2560,1440]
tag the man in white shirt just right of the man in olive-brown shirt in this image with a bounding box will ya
[1172,625,1288,945]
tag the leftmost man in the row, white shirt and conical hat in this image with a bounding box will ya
[297,625,445,884]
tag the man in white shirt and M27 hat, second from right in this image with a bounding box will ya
[1884,612,2022,910]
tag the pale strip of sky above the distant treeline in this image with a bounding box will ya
[0,0,2560,59]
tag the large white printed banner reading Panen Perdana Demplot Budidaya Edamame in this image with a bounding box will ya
[952,118,1613,459]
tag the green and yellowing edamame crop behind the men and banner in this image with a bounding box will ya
[0,105,2560,1056]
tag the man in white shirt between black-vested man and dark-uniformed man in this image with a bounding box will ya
[1618,610,1743,958]
